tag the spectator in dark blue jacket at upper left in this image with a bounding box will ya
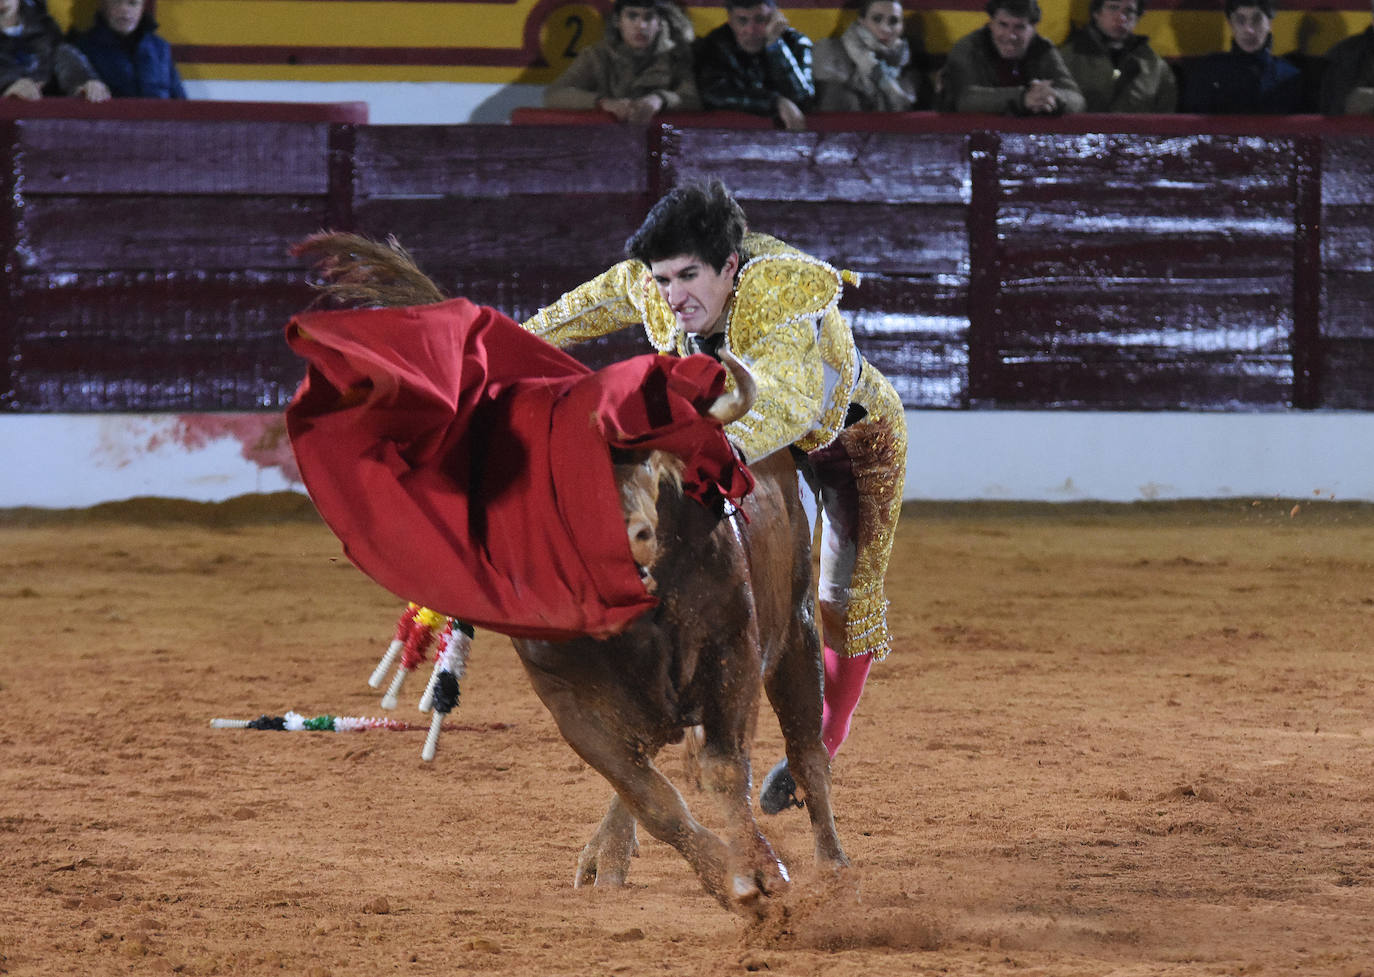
[69,0,185,99]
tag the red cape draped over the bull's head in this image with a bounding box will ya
[286,298,753,640]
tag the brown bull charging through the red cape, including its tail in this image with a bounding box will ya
[289,234,848,912]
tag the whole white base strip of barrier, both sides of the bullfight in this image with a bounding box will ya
[0,411,1374,508]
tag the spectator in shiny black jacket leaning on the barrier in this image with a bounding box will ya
[695,0,816,131]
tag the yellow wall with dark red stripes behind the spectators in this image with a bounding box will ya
[49,0,1370,84]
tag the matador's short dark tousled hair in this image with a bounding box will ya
[625,180,749,272]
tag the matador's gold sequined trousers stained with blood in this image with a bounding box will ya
[801,361,907,661]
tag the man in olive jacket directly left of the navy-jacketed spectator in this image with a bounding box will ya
[1059,0,1179,113]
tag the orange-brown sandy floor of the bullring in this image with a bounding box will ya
[0,496,1374,977]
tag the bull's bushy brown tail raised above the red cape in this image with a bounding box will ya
[291,231,447,308]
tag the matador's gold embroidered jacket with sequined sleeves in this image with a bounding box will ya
[525,234,860,460]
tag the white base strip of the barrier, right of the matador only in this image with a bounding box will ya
[905,411,1374,502]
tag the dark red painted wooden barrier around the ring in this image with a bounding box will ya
[0,103,1374,411]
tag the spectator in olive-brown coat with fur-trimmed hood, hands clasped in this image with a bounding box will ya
[544,0,701,122]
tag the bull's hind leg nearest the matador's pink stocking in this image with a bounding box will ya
[764,628,849,868]
